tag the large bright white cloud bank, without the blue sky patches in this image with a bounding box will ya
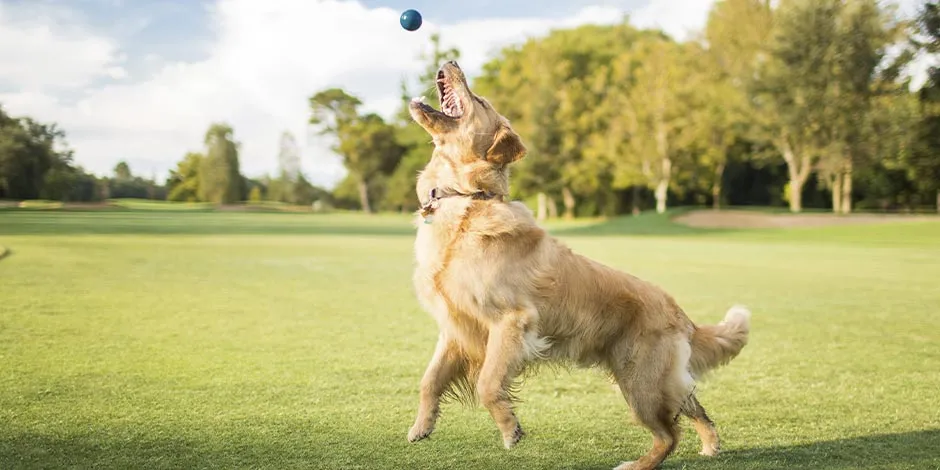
[0,0,710,189]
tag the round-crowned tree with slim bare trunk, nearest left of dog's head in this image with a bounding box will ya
[310,88,405,213]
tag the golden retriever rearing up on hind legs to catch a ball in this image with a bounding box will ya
[408,61,751,470]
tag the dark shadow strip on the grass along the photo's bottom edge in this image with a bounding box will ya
[0,429,940,470]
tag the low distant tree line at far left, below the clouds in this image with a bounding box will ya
[0,107,330,205]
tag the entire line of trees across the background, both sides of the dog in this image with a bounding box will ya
[0,0,940,218]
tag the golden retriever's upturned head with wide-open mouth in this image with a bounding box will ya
[409,61,526,174]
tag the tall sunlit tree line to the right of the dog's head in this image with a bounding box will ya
[477,0,940,215]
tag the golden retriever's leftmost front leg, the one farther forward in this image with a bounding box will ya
[408,334,464,442]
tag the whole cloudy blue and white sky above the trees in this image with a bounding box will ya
[0,0,917,187]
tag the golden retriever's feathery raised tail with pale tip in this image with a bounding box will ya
[689,305,751,377]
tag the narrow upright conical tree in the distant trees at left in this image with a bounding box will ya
[199,123,245,204]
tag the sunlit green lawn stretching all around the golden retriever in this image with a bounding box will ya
[0,211,940,470]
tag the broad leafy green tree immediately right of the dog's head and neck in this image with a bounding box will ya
[474,21,658,217]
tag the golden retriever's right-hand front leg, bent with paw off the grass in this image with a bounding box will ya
[477,309,537,449]
